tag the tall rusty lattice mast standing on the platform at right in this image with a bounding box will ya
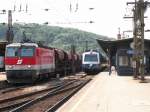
[125,0,150,82]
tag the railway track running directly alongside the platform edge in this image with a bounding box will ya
[10,79,91,112]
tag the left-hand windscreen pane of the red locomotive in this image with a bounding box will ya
[6,47,18,57]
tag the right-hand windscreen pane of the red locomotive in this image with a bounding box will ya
[20,47,34,57]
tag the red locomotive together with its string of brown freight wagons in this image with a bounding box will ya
[5,43,81,83]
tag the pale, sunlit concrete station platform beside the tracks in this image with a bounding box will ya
[57,72,150,112]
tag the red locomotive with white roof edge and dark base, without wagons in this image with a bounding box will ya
[5,43,55,83]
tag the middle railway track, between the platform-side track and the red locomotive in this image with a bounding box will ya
[0,80,79,111]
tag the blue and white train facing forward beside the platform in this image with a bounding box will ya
[82,50,101,73]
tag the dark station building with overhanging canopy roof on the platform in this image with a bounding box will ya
[97,38,150,75]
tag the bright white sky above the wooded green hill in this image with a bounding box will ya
[0,0,150,39]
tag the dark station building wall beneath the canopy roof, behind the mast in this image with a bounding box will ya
[116,42,150,75]
